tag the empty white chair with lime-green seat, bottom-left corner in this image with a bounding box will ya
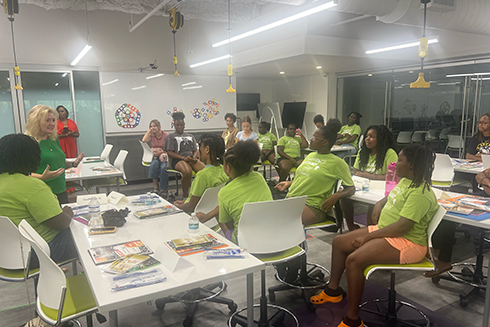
[19,220,97,326]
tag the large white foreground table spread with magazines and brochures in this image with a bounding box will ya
[70,197,265,327]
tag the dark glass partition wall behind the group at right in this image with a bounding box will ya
[337,63,490,157]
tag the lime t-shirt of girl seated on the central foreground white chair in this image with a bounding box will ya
[218,171,272,243]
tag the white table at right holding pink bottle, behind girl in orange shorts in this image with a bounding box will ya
[350,181,490,327]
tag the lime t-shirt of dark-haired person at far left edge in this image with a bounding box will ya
[0,173,61,242]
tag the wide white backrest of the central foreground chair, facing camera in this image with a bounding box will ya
[238,196,306,254]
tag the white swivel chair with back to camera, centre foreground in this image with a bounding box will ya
[228,196,306,326]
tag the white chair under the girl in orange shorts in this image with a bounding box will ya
[359,206,446,326]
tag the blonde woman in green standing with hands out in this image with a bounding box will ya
[26,105,84,204]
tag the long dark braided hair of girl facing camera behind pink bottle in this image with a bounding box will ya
[359,125,398,171]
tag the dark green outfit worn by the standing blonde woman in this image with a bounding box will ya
[36,137,66,194]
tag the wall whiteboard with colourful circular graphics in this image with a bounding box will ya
[100,72,236,134]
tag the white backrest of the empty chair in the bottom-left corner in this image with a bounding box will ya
[19,219,66,310]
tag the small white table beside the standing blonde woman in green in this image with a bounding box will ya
[65,161,123,192]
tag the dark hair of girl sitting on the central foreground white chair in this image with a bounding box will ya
[225,140,260,177]
